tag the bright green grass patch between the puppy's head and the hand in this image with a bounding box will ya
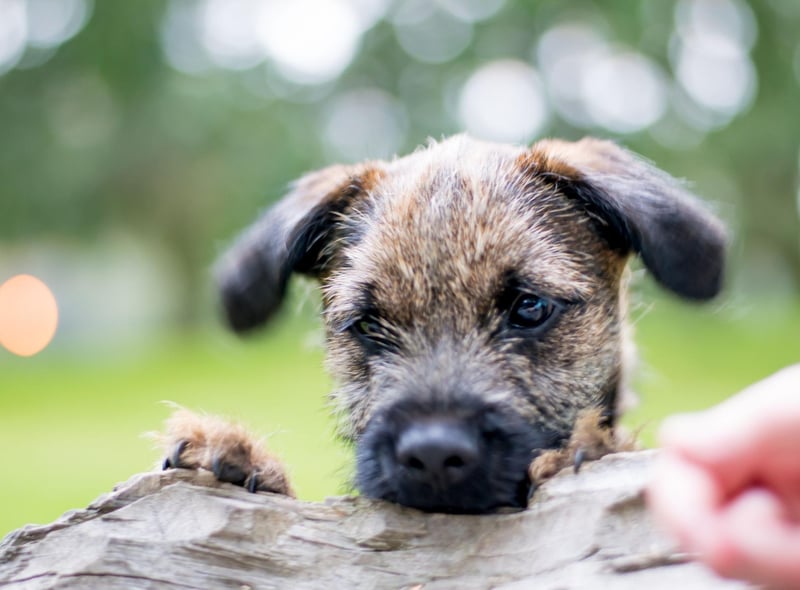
[625,300,800,446]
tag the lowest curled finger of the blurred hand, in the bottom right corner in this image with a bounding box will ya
[700,489,800,588]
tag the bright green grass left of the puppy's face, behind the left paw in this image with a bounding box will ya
[0,312,349,535]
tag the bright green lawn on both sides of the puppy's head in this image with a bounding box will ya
[0,294,800,535]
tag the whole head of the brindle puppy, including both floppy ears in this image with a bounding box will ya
[219,137,725,512]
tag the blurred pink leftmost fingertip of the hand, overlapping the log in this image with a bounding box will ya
[646,452,722,552]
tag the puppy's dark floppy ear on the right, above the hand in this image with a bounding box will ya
[532,138,727,300]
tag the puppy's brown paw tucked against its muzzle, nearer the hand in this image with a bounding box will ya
[528,408,636,494]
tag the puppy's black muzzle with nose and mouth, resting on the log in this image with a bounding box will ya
[356,402,563,514]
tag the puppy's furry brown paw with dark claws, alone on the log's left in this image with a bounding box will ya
[159,408,295,497]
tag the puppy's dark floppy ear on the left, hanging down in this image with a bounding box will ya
[215,163,382,333]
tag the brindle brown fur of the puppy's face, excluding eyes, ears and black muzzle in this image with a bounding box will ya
[323,146,627,439]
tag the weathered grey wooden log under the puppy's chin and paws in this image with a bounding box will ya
[0,451,746,590]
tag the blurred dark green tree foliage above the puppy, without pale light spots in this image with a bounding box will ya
[0,0,800,310]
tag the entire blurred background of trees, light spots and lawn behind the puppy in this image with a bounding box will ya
[0,0,800,535]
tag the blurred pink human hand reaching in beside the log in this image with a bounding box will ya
[647,365,800,588]
